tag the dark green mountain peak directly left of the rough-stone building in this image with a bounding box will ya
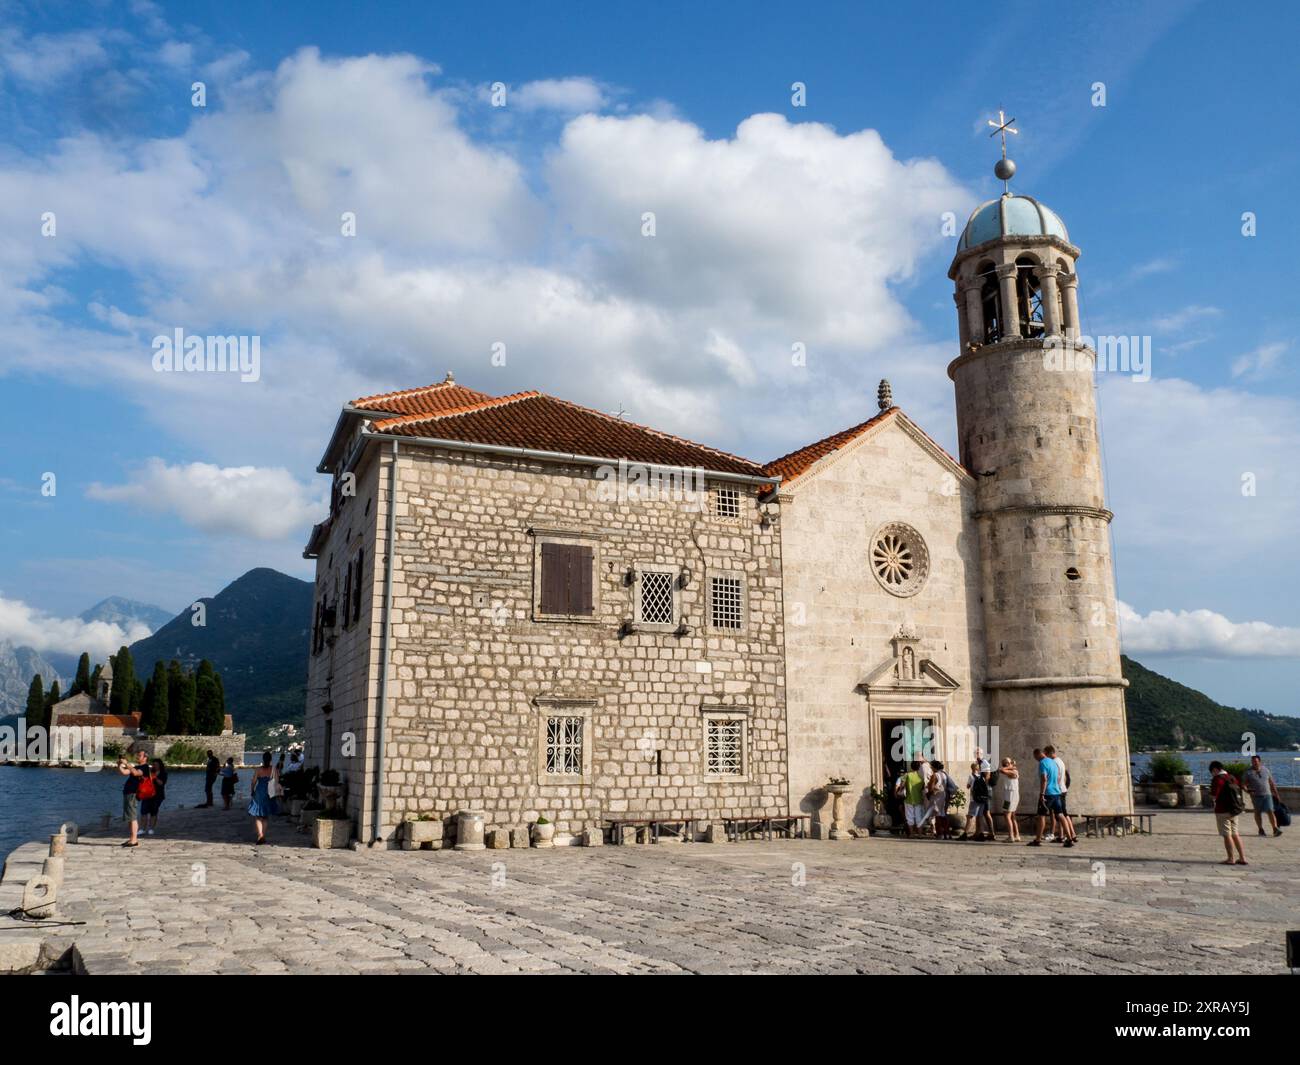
[128,568,315,736]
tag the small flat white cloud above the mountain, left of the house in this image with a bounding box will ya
[86,458,325,541]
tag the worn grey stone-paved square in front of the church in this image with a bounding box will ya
[0,810,1300,974]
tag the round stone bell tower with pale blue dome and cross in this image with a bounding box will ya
[948,133,1132,814]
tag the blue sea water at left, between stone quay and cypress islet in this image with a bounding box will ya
[0,766,220,861]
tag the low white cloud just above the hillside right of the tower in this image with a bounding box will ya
[1119,602,1300,658]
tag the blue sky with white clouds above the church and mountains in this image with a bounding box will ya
[0,3,1300,713]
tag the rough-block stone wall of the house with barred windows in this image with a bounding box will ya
[307,445,788,841]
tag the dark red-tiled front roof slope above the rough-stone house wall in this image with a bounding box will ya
[374,386,763,477]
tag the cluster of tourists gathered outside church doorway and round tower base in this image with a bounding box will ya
[893,744,1079,847]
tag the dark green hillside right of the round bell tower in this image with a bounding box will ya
[1121,655,1300,750]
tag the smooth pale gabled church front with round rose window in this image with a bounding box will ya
[780,411,988,835]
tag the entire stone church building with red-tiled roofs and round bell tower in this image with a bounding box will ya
[304,185,1131,843]
